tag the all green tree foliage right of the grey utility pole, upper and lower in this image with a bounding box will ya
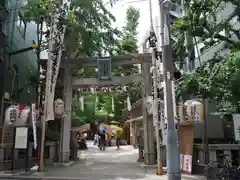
[172,0,240,104]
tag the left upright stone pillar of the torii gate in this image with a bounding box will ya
[60,64,72,163]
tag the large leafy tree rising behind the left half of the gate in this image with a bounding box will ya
[24,0,123,124]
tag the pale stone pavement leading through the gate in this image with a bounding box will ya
[0,141,206,180]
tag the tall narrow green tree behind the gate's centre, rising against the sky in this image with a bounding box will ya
[111,6,141,120]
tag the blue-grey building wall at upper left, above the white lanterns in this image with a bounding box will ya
[2,0,38,111]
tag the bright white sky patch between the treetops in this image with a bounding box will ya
[105,0,159,50]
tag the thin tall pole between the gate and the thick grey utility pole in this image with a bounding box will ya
[149,0,163,175]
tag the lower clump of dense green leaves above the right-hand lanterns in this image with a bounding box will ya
[177,51,240,112]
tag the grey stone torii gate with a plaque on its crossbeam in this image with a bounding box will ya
[60,53,156,164]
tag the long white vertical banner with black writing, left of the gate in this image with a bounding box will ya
[44,0,71,121]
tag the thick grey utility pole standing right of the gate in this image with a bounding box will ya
[159,0,181,180]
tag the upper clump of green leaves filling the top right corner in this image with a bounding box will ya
[172,0,240,67]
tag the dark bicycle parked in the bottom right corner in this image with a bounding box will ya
[205,154,240,180]
